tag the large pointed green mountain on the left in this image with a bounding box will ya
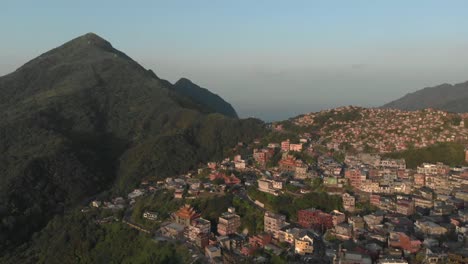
[0,33,264,256]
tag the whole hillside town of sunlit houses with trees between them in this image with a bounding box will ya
[83,108,468,264]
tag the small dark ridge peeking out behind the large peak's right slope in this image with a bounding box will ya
[174,78,237,118]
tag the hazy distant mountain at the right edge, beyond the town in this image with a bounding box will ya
[382,81,468,113]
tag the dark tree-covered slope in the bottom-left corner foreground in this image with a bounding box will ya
[0,211,190,264]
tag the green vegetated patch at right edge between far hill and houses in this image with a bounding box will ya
[384,142,465,169]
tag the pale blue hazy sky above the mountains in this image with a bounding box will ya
[0,0,468,121]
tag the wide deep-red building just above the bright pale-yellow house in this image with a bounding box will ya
[297,208,333,231]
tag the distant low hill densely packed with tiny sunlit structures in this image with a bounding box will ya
[294,106,468,153]
